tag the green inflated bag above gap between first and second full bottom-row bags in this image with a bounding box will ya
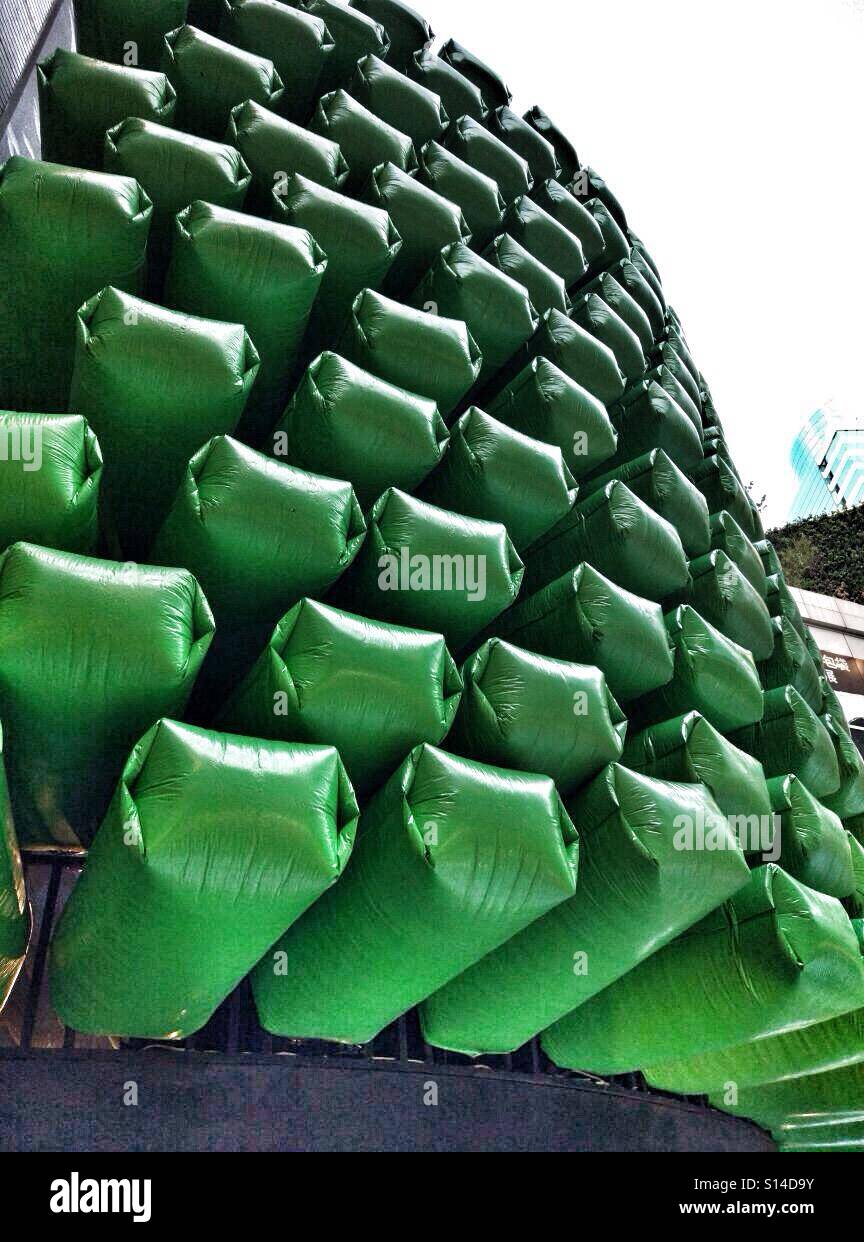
[218,599,462,797]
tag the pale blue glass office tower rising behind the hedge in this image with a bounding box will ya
[790,405,864,522]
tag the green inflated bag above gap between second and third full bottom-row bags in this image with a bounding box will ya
[447,638,627,796]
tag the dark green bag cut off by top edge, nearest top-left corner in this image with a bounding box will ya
[74,0,189,70]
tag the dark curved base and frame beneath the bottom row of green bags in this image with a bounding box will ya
[0,851,775,1153]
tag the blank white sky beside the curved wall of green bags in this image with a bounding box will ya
[412,0,864,524]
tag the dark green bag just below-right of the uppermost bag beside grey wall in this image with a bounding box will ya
[104,117,251,294]
